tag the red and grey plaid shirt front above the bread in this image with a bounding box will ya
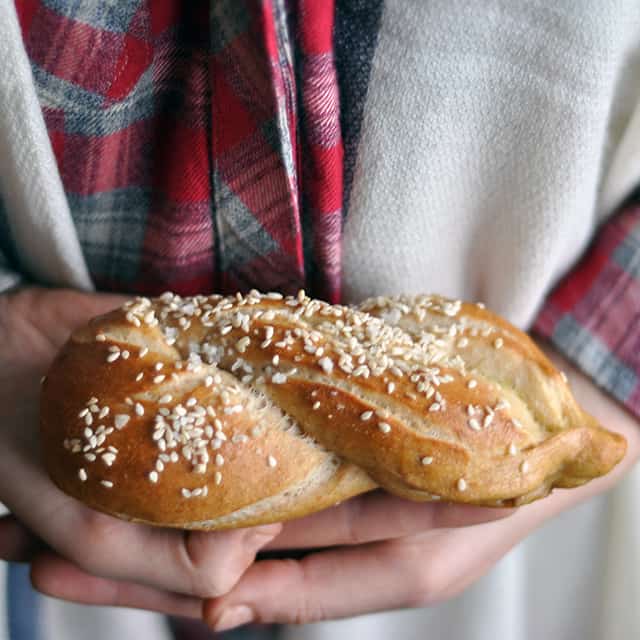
[16,0,342,301]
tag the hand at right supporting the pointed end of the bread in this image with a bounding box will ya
[204,340,640,631]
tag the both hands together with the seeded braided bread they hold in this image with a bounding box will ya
[0,289,640,629]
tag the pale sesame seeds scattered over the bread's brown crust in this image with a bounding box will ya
[63,291,528,499]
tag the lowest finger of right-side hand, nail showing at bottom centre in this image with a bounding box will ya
[203,543,414,631]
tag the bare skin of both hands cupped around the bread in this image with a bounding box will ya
[0,288,640,630]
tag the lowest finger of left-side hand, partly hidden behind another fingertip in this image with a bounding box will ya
[31,554,202,618]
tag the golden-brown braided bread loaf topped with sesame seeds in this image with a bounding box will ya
[41,292,626,529]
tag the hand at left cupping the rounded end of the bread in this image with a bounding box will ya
[0,288,281,618]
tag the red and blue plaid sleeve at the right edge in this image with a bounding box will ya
[534,198,640,417]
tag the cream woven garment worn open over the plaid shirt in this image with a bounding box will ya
[0,0,640,640]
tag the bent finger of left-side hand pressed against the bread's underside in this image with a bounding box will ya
[0,444,281,597]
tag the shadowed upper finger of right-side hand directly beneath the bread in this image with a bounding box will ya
[266,491,514,549]
